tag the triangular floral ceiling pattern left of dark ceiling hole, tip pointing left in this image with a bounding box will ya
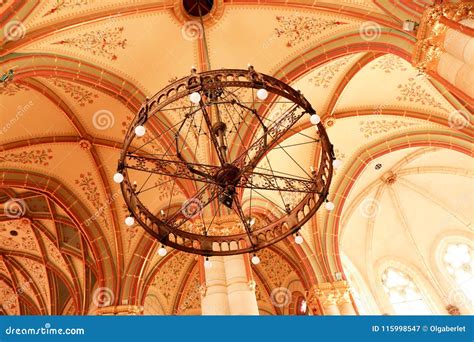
[53,27,127,61]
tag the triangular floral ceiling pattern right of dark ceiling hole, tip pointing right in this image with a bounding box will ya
[275,15,347,47]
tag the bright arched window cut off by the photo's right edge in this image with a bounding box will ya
[443,243,474,303]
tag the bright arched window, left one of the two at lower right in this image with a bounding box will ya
[382,267,432,315]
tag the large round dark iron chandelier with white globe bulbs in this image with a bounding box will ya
[114,66,340,255]
